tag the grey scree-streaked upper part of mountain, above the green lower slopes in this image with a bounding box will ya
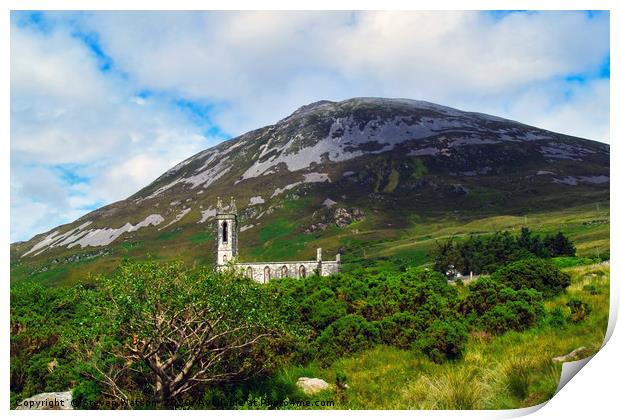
[12,97,609,266]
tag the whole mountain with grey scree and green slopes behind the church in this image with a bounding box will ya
[11,98,610,281]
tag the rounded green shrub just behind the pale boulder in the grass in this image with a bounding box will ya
[316,315,379,362]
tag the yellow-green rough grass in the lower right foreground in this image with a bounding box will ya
[256,264,609,409]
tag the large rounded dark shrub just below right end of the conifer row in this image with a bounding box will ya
[492,258,570,297]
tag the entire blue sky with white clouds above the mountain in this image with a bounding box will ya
[10,11,610,242]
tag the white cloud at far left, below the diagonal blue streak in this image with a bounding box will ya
[11,21,213,240]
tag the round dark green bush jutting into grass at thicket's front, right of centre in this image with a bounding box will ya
[418,318,467,363]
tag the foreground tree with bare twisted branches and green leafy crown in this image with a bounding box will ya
[77,262,282,407]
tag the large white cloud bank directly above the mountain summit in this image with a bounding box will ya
[83,11,609,134]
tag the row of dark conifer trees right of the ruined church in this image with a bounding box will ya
[432,227,575,273]
